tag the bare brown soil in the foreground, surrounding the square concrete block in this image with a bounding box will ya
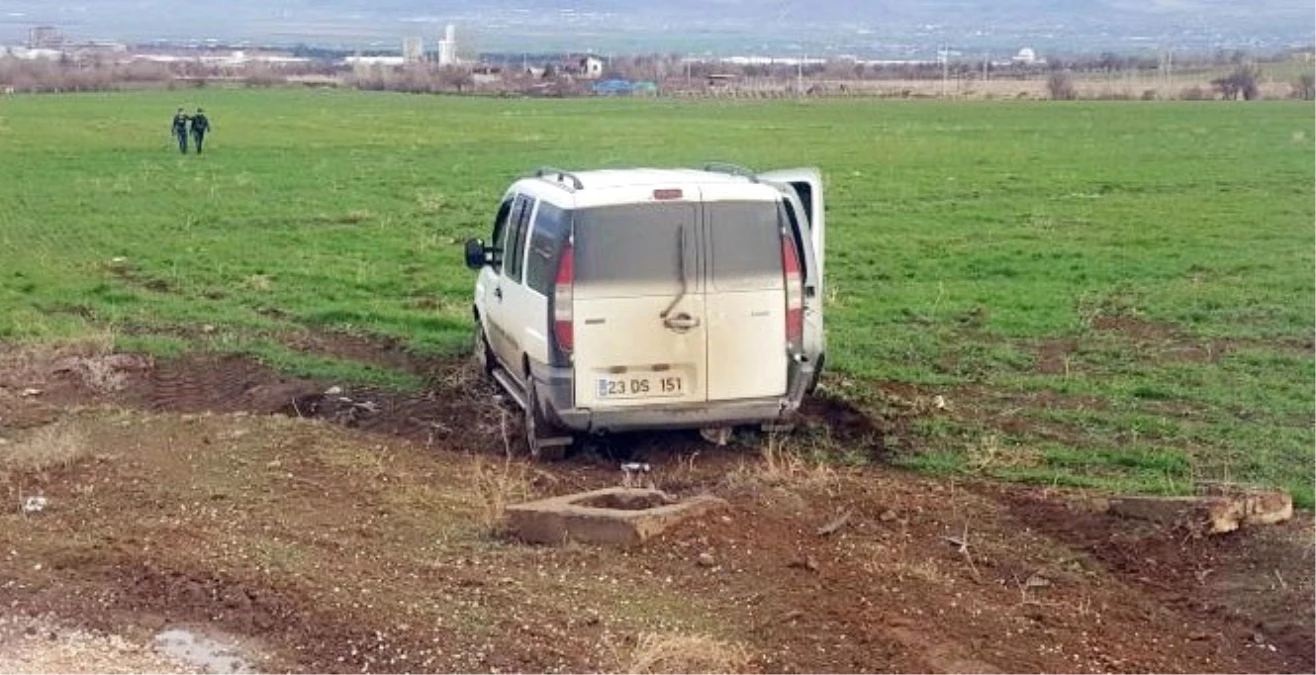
[0,347,1316,674]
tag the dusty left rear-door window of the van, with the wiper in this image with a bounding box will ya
[574,201,697,297]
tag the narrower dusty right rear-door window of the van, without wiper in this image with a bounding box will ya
[704,201,786,291]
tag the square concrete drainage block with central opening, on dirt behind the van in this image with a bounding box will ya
[507,487,726,546]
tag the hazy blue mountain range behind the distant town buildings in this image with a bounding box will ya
[0,0,1316,58]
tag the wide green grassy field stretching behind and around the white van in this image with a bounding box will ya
[0,89,1316,507]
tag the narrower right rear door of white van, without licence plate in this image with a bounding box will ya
[703,183,787,401]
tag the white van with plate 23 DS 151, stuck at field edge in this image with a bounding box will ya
[466,164,826,457]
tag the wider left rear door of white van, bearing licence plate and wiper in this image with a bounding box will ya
[572,192,708,409]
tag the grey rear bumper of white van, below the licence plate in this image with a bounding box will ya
[532,362,813,433]
